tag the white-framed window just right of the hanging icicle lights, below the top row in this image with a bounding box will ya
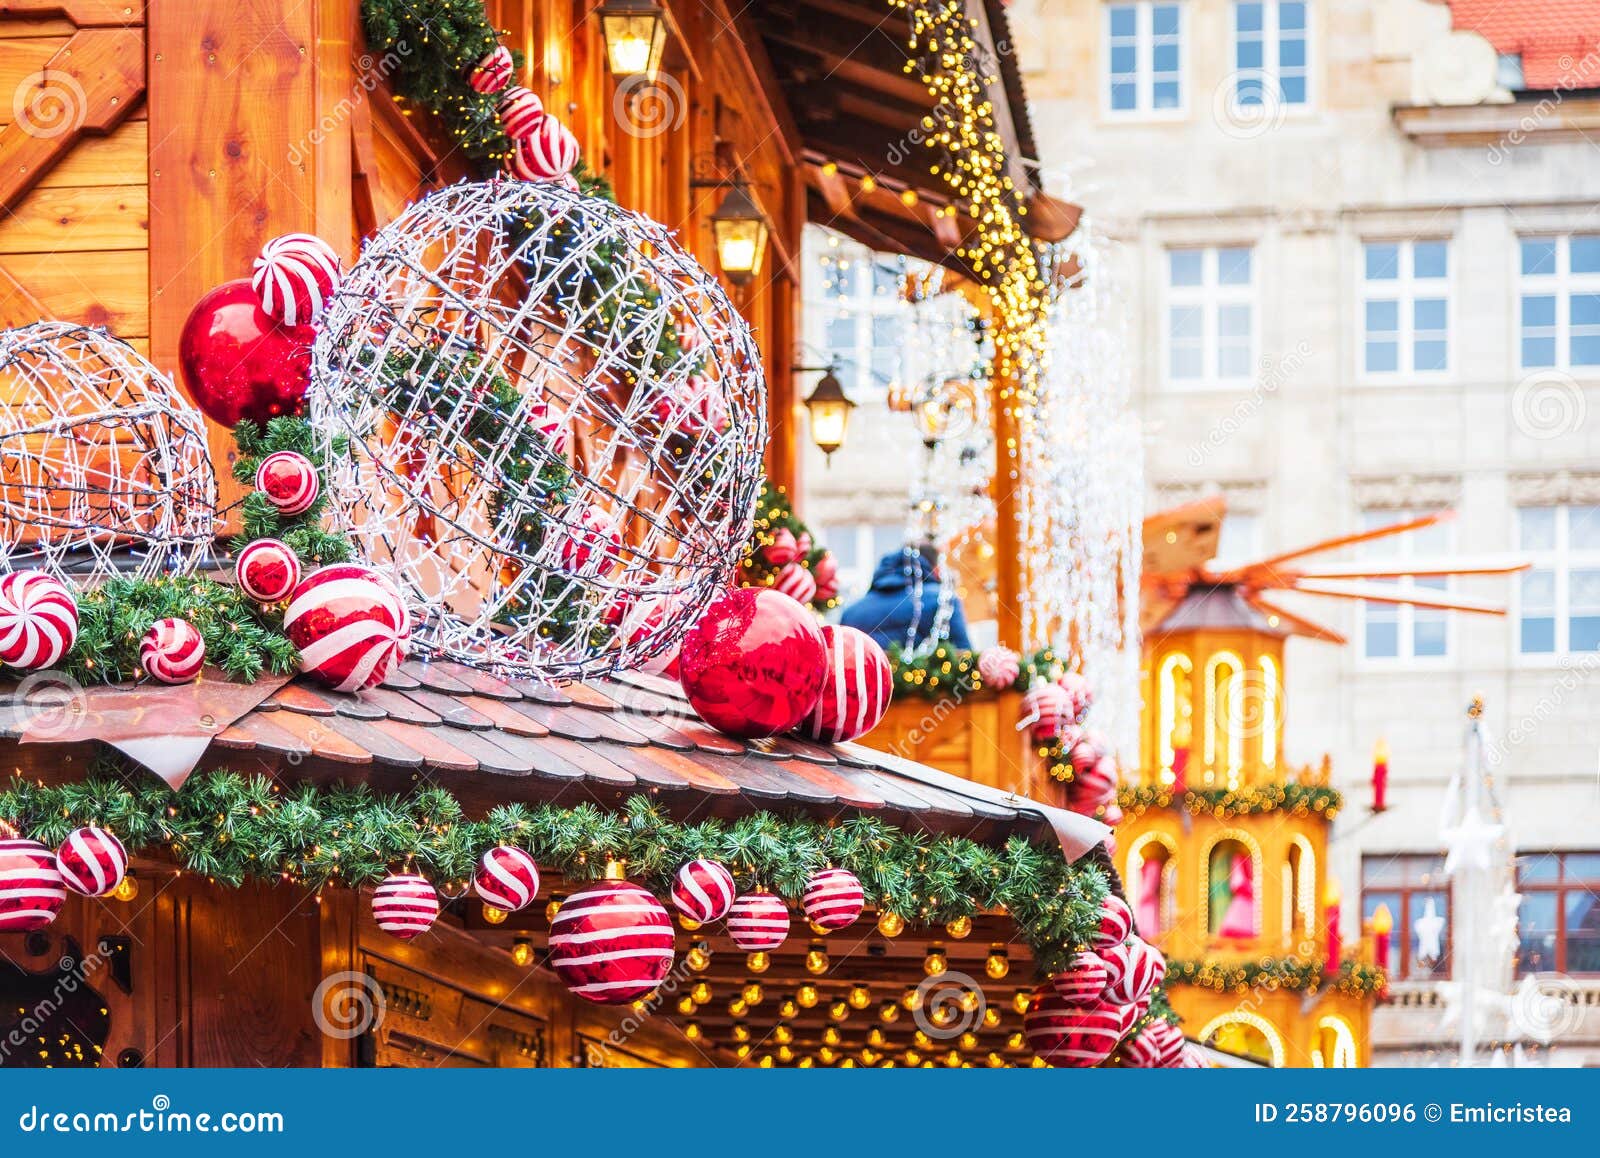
[1165,245,1256,385]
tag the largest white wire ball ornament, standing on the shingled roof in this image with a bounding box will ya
[310,181,766,678]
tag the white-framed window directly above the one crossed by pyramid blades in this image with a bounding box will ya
[1360,240,1450,377]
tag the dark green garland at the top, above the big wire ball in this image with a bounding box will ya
[362,0,522,168]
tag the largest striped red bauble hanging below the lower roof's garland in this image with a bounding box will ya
[550,881,674,1004]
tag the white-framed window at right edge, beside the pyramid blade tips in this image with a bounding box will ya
[1517,505,1600,656]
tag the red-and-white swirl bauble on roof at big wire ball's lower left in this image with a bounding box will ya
[283,563,408,691]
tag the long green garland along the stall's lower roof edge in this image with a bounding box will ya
[9,771,1107,972]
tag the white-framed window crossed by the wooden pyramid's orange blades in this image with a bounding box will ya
[1362,509,1454,664]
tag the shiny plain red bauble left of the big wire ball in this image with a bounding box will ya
[178,278,317,427]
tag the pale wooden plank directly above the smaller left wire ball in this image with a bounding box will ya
[0,250,147,332]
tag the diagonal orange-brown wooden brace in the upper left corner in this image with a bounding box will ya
[0,29,144,206]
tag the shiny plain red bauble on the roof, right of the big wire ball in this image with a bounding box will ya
[678,587,827,739]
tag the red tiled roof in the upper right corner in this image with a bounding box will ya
[1450,0,1600,90]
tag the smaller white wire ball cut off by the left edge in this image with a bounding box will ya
[0,321,216,584]
